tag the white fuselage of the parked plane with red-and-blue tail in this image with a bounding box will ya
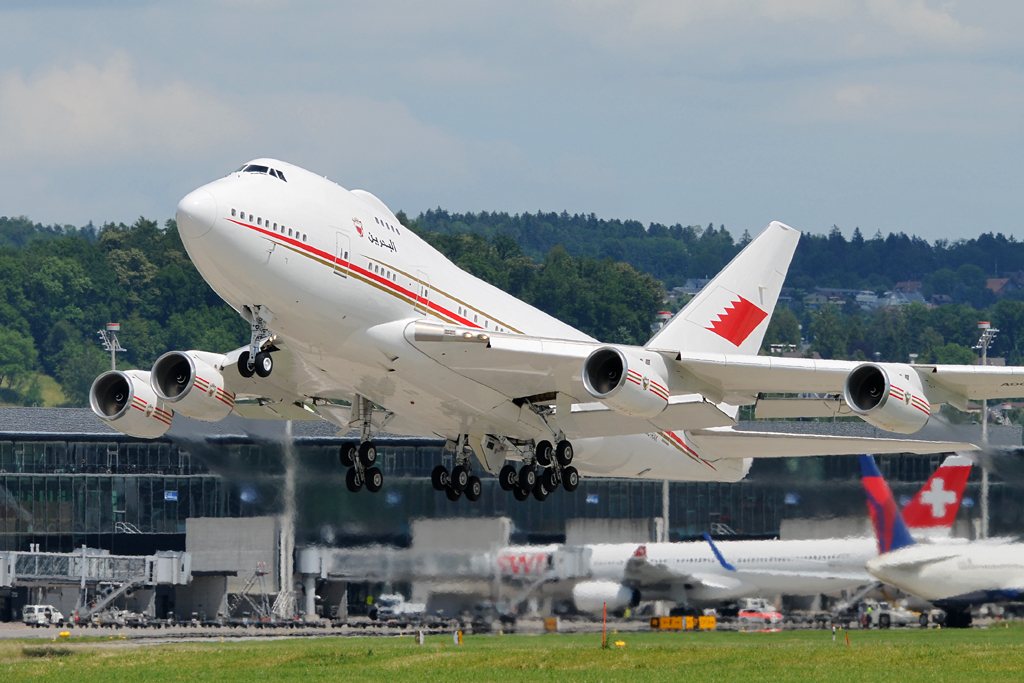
[867,542,1024,606]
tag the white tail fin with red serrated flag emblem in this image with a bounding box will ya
[647,222,800,355]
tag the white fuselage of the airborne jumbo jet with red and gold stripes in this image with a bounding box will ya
[178,160,751,481]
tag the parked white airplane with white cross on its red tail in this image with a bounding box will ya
[552,456,971,612]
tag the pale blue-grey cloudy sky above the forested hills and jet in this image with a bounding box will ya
[0,0,1024,240]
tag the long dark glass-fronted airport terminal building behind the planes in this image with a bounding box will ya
[0,408,1022,620]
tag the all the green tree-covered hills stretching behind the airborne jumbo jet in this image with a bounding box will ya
[0,209,1024,405]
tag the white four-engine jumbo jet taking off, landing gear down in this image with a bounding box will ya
[90,159,1024,500]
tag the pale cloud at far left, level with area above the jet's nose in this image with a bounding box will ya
[0,55,250,163]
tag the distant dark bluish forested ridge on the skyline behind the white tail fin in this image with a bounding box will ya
[410,209,1024,308]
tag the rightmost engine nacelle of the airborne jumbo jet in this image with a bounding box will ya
[843,362,932,434]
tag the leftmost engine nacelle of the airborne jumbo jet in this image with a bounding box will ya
[89,370,174,438]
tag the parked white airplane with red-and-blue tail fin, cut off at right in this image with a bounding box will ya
[861,456,1024,628]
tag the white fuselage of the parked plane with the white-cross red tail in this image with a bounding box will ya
[590,538,878,602]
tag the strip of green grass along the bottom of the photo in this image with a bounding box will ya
[0,628,1024,683]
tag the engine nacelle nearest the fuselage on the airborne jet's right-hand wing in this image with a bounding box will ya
[583,346,669,418]
